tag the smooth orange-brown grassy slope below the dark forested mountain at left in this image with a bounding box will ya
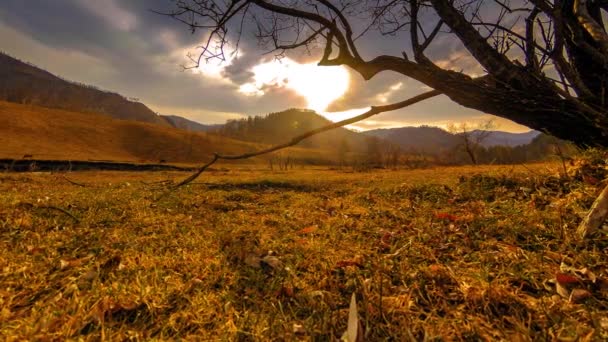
[0,101,256,163]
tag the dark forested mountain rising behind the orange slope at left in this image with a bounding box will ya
[0,53,171,127]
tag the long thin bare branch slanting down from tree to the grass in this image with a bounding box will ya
[171,90,441,190]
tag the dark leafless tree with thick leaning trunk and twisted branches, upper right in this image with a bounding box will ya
[160,0,608,146]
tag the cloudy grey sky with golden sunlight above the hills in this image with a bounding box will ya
[0,0,529,132]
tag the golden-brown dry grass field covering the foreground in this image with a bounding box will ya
[0,164,608,341]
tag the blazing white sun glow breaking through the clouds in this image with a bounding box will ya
[239,58,349,113]
